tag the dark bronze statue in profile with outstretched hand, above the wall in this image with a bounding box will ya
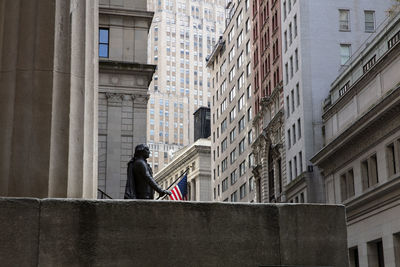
[124,144,171,199]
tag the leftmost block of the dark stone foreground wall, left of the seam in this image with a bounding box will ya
[0,198,40,266]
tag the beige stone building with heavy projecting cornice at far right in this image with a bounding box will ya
[312,10,400,267]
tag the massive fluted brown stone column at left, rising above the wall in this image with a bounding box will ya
[0,0,98,198]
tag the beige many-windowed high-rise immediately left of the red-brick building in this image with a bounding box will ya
[207,0,255,202]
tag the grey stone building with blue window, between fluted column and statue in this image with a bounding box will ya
[98,0,156,198]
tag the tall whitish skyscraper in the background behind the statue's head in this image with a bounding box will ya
[147,0,225,172]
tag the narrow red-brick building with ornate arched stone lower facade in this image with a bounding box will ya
[252,0,286,202]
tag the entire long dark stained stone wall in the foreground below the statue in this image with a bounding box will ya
[0,198,348,267]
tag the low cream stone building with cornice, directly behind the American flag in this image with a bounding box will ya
[154,139,212,201]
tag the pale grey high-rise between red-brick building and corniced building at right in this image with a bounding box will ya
[280,0,392,202]
